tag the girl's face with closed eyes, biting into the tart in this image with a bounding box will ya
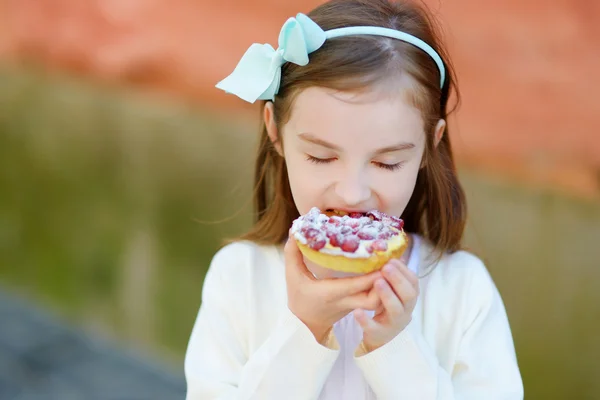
[265,87,437,220]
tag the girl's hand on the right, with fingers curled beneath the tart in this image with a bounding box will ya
[354,259,419,351]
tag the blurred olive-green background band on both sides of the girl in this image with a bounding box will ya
[0,67,600,399]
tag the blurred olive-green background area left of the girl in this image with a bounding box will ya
[0,68,255,357]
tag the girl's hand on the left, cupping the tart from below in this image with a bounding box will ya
[284,238,382,343]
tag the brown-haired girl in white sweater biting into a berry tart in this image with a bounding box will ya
[185,0,523,400]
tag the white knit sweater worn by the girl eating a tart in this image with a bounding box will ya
[185,236,523,400]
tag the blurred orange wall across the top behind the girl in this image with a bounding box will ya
[0,0,600,196]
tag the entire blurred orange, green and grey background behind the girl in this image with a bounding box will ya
[0,0,600,399]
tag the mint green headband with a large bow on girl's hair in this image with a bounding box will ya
[216,14,446,103]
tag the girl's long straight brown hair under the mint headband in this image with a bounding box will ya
[240,0,466,256]
